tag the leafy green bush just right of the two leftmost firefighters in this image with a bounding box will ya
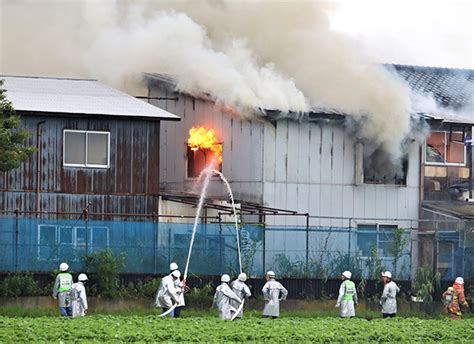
[84,249,125,298]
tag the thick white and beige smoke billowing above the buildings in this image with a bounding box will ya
[0,0,410,159]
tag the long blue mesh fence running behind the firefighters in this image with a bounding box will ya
[0,211,474,279]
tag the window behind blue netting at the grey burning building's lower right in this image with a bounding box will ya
[357,224,398,257]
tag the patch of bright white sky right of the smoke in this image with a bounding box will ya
[328,0,474,69]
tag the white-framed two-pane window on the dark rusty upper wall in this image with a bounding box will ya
[63,129,110,168]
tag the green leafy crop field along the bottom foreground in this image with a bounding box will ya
[0,315,474,343]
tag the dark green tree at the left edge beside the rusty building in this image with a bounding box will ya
[0,80,36,171]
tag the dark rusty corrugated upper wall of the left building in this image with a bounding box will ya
[0,114,160,213]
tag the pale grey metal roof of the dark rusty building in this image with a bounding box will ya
[0,75,179,120]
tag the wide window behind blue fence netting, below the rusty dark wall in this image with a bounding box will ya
[38,225,109,261]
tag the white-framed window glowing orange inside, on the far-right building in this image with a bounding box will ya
[425,131,466,166]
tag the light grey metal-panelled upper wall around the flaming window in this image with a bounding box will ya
[150,85,420,228]
